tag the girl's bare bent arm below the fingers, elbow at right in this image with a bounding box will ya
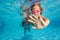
[32,16,50,29]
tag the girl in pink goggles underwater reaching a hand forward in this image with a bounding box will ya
[28,2,49,29]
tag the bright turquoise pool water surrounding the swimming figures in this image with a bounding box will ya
[0,0,60,40]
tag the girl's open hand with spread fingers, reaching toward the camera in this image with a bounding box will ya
[28,15,43,29]
